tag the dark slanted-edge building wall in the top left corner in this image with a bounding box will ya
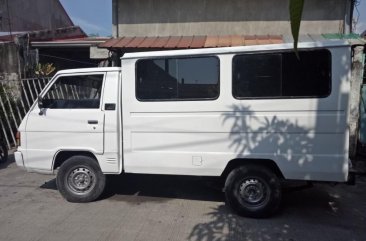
[0,0,73,32]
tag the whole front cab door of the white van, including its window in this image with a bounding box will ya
[25,72,105,170]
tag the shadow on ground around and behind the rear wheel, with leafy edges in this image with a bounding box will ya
[187,182,366,241]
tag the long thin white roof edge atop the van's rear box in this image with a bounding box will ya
[121,40,350,60]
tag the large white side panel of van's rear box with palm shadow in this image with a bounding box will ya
[122,44,350,181]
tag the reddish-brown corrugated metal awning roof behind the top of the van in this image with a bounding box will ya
[99,35,284,49]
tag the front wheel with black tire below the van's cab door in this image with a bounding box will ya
[56,156,106,203]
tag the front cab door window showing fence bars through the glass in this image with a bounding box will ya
[43,74,104,109]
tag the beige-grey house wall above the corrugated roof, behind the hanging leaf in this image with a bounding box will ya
[113,0,348,37]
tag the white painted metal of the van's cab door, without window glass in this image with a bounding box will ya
[23,72,105,172]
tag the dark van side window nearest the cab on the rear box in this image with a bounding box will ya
[136,57,219,101]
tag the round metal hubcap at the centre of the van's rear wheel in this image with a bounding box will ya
[239,178,266,204]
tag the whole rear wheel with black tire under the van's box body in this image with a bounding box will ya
[225,165,281,218]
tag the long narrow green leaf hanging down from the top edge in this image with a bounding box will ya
[289,0,305,58]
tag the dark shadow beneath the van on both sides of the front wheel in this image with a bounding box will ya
[40,174,224,202]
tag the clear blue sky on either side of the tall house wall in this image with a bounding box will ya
[60,0,366,36]
